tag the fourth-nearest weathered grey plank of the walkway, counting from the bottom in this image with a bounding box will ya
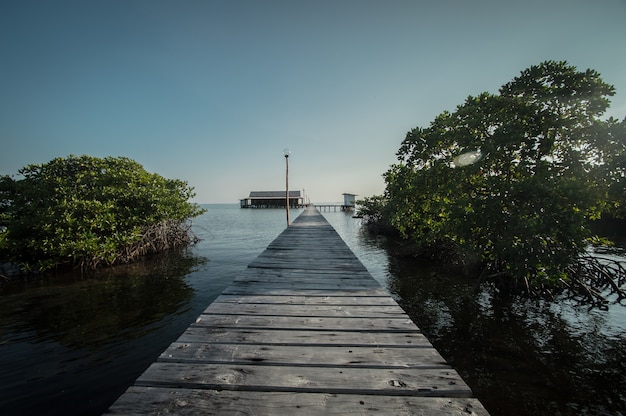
[177,325,431,348]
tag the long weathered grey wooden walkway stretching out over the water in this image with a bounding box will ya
[108,207,488,415]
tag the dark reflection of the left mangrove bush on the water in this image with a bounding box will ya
[0,253,200,347]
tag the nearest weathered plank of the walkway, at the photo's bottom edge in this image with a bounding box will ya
[109,387,488,416]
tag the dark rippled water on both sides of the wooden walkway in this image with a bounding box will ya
[0,205,626,416]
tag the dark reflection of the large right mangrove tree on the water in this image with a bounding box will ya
[388,254,626,415]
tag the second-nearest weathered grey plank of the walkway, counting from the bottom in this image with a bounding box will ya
[135,362,472,397]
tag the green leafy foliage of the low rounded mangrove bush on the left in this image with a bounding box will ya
[0,156,203,270]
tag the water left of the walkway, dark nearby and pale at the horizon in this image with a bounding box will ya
[0,205,301,415]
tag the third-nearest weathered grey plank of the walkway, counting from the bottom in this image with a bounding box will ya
[159,342,448,368]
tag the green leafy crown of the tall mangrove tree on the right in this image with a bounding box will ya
[376,61,626,296]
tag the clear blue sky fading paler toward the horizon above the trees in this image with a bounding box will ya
[0,0,626,203]
